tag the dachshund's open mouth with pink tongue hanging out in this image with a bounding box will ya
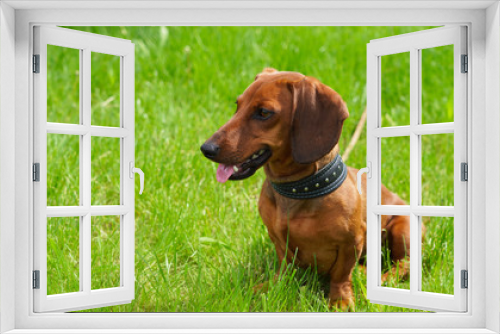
[217,148,272,183]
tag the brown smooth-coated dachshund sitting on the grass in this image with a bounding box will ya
[201,69,410,310]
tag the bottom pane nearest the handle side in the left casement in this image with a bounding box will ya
[92,216,120,289]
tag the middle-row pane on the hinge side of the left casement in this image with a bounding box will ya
[47,133,80,206]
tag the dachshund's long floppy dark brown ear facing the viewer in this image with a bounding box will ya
[291,77,349,164]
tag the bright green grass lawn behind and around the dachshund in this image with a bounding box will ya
[48,27,453,312]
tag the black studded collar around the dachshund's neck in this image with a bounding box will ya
[271,154,347,199]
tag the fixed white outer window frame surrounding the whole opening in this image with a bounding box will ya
[0,0,500,333]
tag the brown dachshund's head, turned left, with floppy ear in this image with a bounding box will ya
[201,68,349,182]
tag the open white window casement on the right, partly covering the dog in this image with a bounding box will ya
[367,26,467,312]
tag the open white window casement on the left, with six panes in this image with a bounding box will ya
[33,26,135,312]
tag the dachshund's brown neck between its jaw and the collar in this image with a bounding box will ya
[264,145,339,183]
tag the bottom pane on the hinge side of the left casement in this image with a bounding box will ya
[47,217,80,295]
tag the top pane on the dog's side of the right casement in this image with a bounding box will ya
[381,52,410,126]
